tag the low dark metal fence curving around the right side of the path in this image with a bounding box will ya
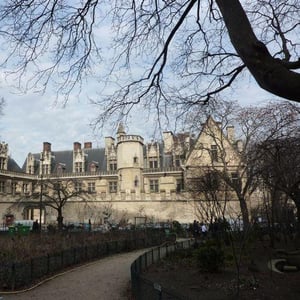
[130,239,193,300]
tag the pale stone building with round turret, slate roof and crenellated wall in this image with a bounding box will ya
[0,118,258,224]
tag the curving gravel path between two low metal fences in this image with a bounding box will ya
[0,249,147,300]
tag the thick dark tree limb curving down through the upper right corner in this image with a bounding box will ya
[216,0,300,102]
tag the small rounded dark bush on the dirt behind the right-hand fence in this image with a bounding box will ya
[196,244,225,273]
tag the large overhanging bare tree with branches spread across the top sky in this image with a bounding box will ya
[0,0,300,130]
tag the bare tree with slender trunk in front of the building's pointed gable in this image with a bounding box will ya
[185,101,298,228]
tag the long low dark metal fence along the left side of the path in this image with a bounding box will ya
[0,232,166,291]
